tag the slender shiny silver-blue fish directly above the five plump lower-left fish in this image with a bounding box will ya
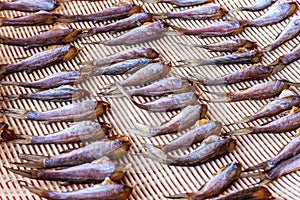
[3,86,90,102]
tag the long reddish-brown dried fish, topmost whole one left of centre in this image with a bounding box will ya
[57,1,143,23]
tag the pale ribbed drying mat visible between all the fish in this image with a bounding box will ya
[0,0,300,200]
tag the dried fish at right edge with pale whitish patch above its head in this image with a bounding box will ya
[236,90,300,123]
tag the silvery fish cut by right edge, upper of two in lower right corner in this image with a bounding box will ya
[244,135,300,172]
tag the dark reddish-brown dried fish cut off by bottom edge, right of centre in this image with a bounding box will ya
[215,186,274,200]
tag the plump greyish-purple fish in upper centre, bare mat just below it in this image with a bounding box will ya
[103,21,169,46]
